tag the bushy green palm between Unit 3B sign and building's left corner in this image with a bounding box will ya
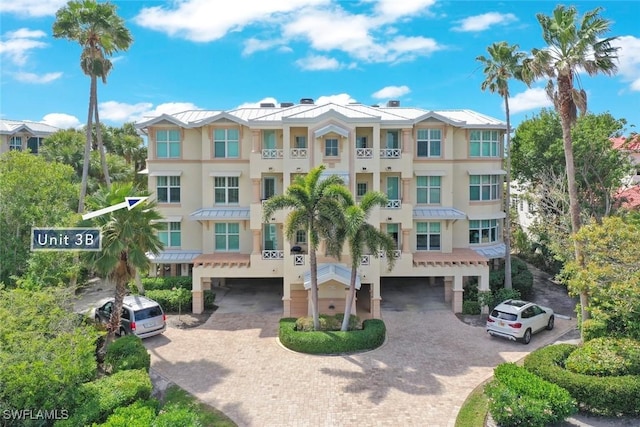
[87,183,163,349]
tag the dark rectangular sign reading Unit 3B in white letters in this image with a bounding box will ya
[31,228,102,251]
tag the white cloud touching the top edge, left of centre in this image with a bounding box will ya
[134,0,329,42]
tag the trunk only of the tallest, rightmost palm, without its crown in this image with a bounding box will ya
[558,75,591,334]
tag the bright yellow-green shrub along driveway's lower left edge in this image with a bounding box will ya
[55,369,151,427]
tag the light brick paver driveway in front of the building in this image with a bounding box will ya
[145,310,575,427]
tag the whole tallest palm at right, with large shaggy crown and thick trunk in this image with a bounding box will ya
[522,5,618,330]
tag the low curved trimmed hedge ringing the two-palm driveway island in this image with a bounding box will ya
[279,317,386,354]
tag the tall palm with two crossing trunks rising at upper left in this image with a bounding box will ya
[53,0,133,213]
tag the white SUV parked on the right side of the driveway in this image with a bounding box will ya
[487,299,555,344]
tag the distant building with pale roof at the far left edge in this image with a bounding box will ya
[0,119,60,154]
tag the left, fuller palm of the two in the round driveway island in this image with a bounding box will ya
[263,165,351,330]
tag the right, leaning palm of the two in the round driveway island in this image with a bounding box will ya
[339,191,396,331]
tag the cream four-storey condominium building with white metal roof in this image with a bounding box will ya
[137,99,506,317]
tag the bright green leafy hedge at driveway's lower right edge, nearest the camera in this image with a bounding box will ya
[485,363,577,427]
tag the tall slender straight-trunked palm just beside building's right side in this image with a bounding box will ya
[476,42,526,289]
